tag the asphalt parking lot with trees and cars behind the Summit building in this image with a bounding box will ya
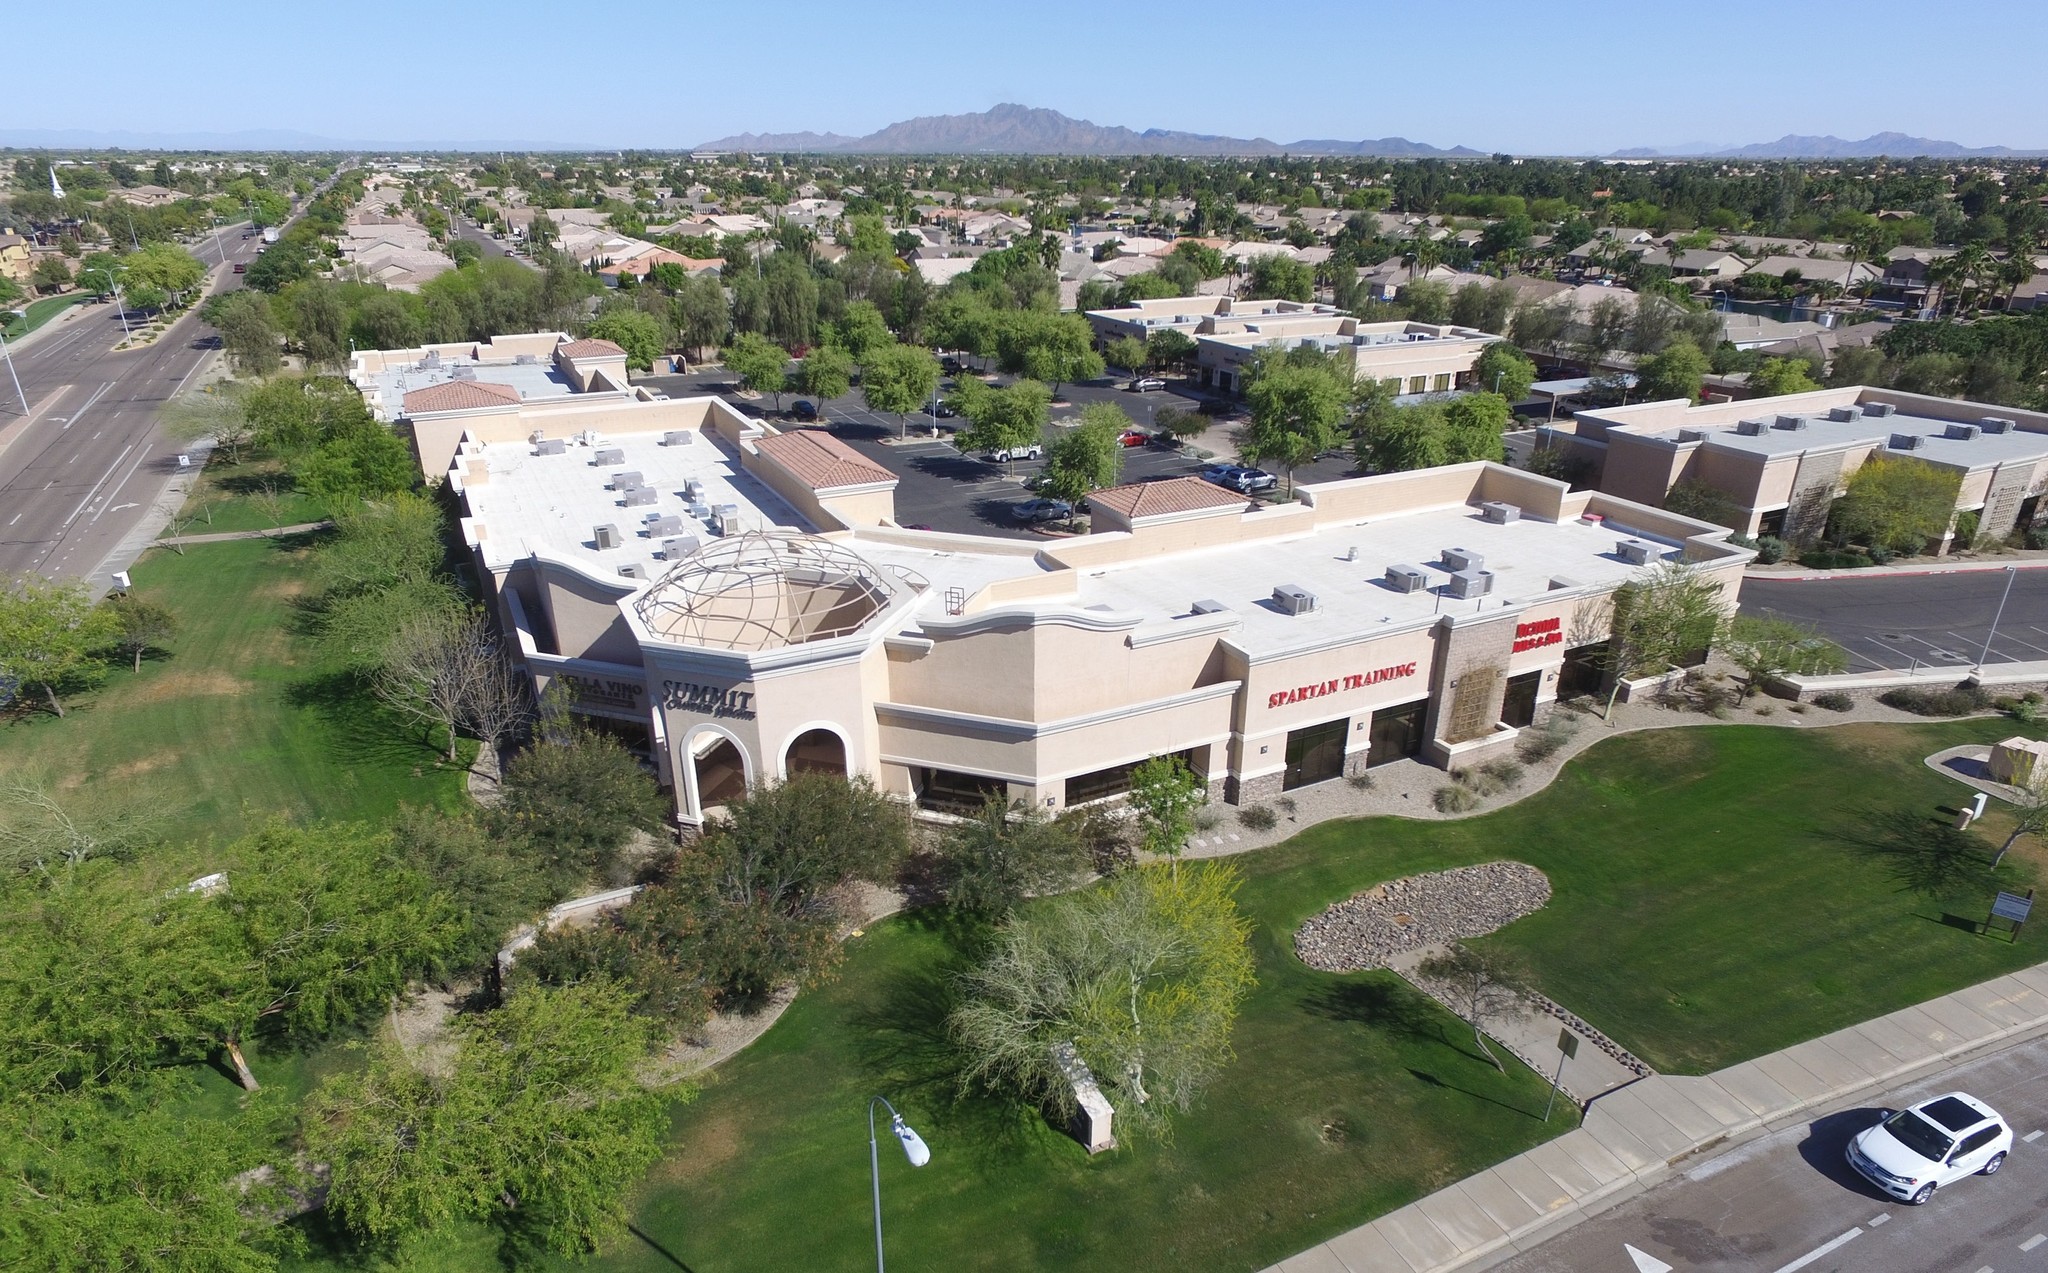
[635,368,1356,538]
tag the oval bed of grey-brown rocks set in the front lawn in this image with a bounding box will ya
[1294,862,1550,972]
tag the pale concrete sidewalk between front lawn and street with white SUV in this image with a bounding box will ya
[1268,964,2048,1273]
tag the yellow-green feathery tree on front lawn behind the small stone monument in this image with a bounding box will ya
[950,864,1253,1134]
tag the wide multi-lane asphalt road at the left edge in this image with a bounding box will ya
[0,229,262,583]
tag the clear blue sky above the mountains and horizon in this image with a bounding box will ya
[16,0,2048,153]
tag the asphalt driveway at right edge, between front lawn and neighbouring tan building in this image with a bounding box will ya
[1743,569,2048,671]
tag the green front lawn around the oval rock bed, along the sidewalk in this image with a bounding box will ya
[292,720,2042,1273]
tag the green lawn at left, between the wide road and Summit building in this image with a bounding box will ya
[0,540,463,839]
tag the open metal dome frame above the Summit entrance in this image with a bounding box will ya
[633,530,897,651]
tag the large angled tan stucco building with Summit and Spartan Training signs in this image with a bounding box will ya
[420,378,1749,823]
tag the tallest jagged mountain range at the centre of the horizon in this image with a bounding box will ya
[696,102,1485,160]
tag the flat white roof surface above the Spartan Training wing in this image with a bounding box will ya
[1079,506,1679,657]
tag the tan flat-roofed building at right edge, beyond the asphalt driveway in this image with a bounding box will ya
[1548,387,2048,551]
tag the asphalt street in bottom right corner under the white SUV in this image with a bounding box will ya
[1495,1040,2048,1273]
